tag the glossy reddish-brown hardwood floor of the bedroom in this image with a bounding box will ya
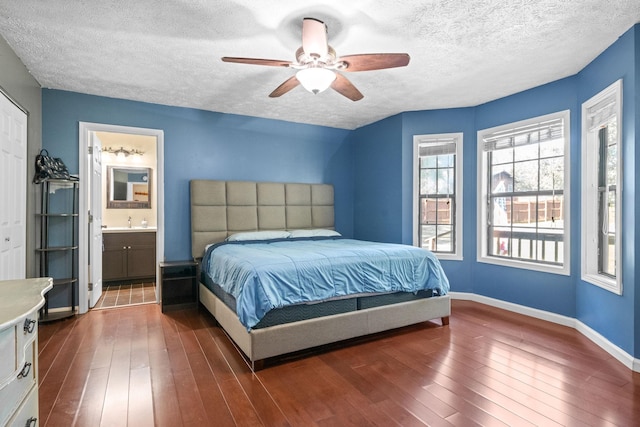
[39,301,640,427]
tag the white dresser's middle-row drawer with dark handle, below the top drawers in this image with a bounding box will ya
[0,340,37,425]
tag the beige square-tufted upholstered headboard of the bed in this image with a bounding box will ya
[191,180,334,258]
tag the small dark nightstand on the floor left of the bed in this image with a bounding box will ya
[160,261,198,313]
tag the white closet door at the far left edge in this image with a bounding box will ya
[0,93,28,280]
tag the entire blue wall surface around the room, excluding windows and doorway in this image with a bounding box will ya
[42,25,640,357]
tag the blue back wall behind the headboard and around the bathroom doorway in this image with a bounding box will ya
[42,89,353,260]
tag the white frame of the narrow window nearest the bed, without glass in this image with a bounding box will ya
[412,132,464,261]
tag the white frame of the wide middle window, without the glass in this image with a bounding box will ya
[477,110,571,276]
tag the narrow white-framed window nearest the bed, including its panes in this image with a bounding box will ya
[413,133,462,259]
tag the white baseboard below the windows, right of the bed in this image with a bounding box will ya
[449,292,640,372]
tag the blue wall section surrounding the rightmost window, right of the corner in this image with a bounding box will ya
[576,25,640,356]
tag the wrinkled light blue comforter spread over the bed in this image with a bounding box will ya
[203,237,449,330]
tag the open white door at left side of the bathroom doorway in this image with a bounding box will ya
[89,132,102,307]
